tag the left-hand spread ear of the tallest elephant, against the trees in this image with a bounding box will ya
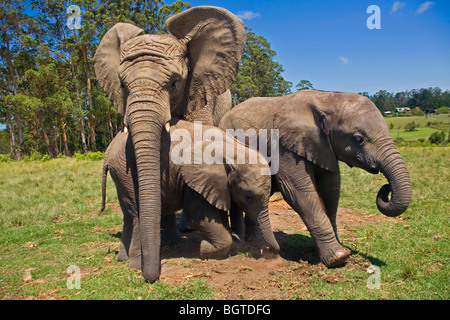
[94,23,144,116]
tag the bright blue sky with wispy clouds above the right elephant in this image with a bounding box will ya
[185,0,450,94]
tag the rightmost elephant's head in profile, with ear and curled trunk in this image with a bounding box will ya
[274,90,411,217]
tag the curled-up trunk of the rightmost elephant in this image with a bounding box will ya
[377,143,411,217]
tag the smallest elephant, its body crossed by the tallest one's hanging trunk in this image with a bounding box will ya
[102,120,279,268]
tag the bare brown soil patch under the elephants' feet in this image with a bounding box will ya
[157,197,394,300]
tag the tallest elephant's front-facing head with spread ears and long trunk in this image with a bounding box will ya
[93,6,245,282]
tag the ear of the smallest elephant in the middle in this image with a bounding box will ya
[181,141,231,211]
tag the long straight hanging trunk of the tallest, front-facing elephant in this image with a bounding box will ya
[127,101,166,282]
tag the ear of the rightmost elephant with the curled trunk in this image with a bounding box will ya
[274,100,339,172]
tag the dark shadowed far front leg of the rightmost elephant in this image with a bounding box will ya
[316,170,341,241]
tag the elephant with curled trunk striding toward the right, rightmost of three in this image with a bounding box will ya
[219,90,411,267]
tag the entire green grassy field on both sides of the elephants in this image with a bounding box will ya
[0,147,450,300]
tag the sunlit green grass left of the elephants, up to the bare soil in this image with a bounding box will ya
[0,159,213,299]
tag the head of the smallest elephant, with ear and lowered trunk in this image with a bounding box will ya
[181,136,280,252]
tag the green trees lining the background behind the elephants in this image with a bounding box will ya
[0,0,450,159]
